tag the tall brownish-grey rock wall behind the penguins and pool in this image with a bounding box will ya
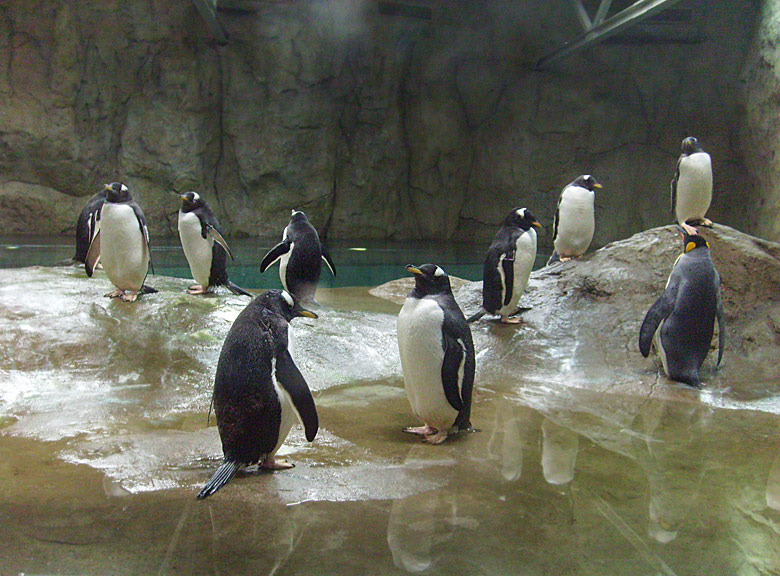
[0,0,758,246]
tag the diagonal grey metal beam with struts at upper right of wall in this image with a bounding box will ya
[536,0,681,70]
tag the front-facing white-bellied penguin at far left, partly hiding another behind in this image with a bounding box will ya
[85,182,156,302]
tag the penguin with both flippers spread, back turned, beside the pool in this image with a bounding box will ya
[260,210,336,302]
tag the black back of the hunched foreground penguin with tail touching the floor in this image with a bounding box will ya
[214,298,287,464]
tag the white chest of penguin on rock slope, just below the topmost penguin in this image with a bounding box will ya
[554,186,596,257]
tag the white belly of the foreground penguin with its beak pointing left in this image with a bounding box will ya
[398,298,458,430]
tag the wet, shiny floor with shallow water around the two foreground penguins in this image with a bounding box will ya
[0,268,780,575]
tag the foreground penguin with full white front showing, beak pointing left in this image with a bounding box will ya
[398,264,476,444]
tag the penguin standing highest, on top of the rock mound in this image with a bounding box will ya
[671,136,712,235]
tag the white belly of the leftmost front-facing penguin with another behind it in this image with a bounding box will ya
[100,203,149,291]
